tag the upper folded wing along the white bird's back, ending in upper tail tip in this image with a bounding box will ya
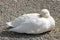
[6,13,39,27]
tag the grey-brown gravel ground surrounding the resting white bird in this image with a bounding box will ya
[0,0,60,40]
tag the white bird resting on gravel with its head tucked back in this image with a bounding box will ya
[7,9,55,34]
